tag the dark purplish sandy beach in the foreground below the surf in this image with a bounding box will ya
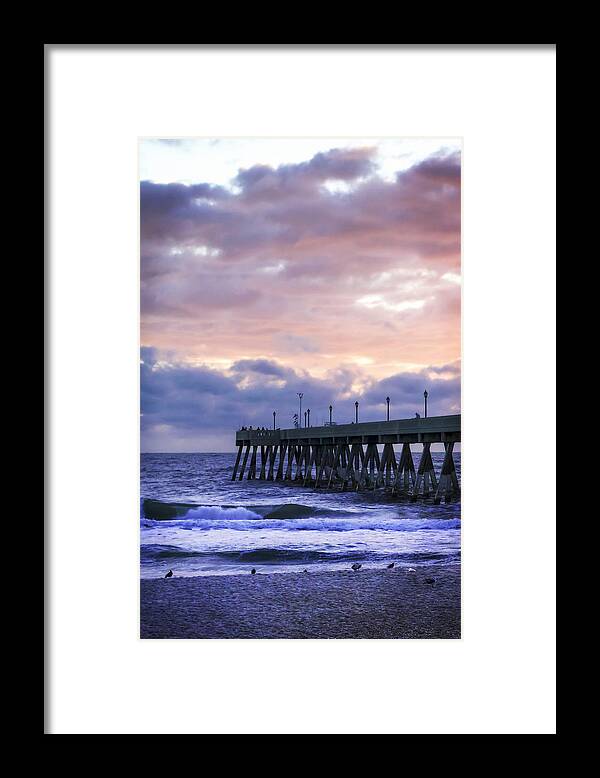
[140,565,460,638]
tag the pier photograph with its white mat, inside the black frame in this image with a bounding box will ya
[45,44,556,735]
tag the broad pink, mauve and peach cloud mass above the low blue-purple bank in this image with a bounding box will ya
[140,147,460,375]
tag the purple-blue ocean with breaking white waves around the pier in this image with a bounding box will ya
[140,452,460,579]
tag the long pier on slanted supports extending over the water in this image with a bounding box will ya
[231,414,460,504]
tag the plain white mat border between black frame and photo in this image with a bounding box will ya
[47,47,555,734]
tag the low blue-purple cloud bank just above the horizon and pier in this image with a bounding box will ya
[140,348,460,451]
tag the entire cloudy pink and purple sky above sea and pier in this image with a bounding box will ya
[140,138,461,452]
